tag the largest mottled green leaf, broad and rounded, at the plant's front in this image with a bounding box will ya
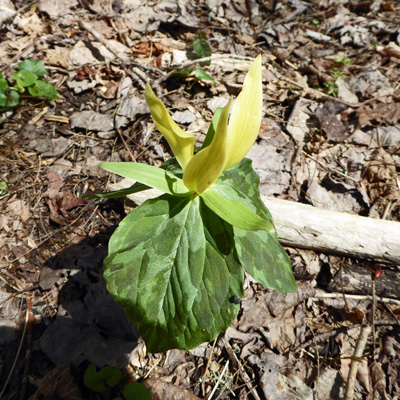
[104,195,243,352]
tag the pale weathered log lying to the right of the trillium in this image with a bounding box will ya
[263,197,400,265]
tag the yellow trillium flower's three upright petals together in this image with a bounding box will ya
[145,55,262,195]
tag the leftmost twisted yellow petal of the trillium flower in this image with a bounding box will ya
[145,83,196,169]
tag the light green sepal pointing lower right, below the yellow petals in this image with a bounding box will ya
[200,185,275,232]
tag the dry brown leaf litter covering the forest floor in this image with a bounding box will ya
[0,0,400,399]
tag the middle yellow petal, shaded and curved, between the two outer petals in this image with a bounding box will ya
[183,98,232,194]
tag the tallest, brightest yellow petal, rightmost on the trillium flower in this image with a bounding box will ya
[224,55,262,170]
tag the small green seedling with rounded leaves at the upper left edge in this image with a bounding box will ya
[0,60,58,108]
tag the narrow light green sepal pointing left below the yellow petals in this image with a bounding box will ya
[100,162,193,196]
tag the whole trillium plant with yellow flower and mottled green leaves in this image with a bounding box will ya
[92,56,296,352]
